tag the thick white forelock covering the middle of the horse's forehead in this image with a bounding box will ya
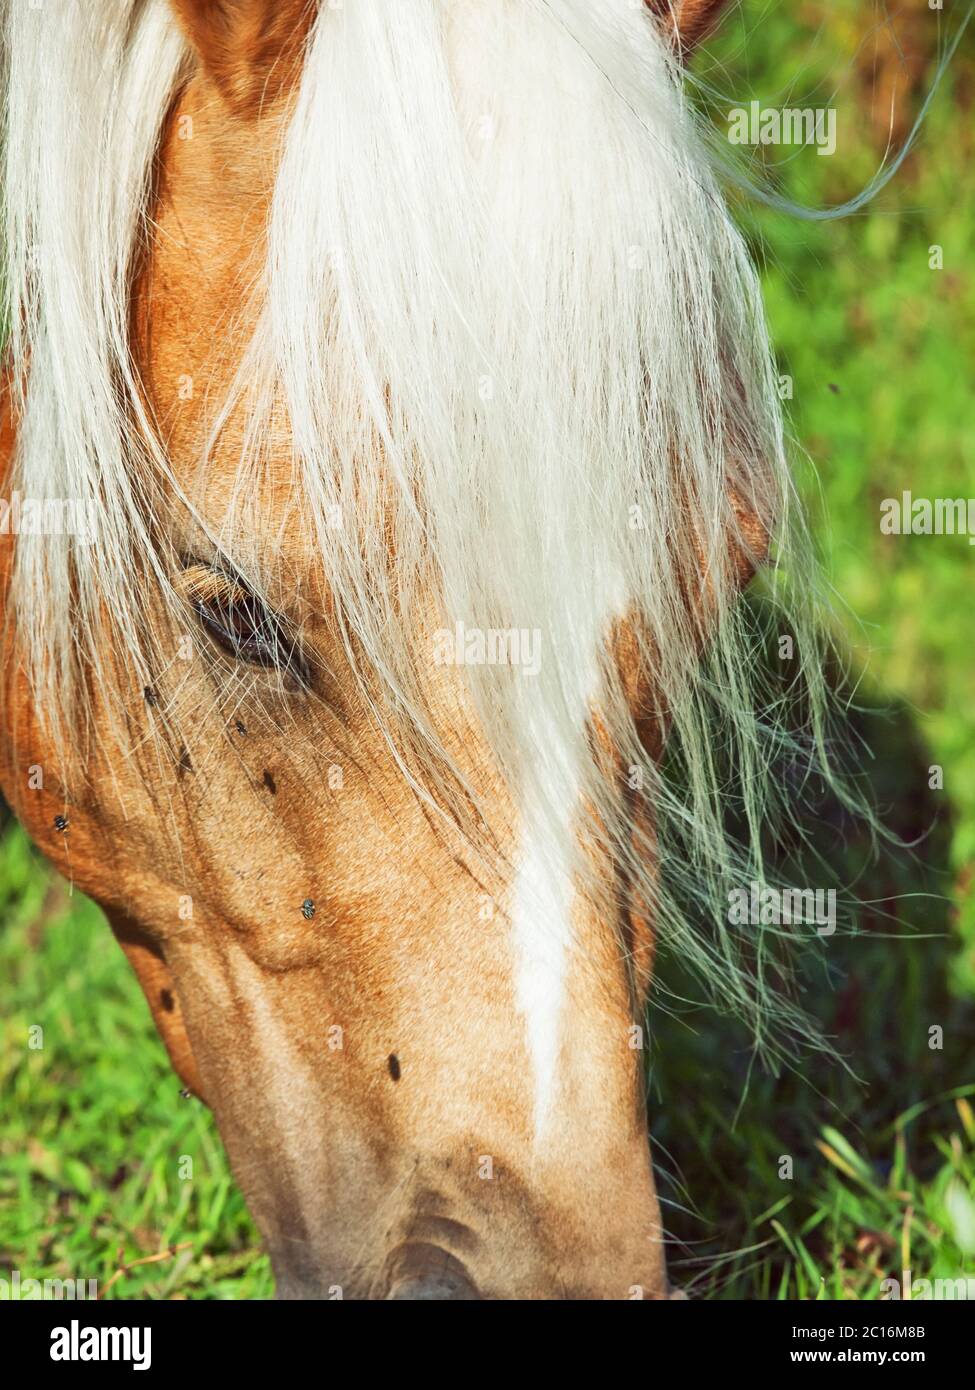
[258,0,780,752]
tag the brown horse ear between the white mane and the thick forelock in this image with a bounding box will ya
[171,0,317,117]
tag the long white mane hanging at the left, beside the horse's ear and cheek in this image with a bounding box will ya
[3,0,186,735]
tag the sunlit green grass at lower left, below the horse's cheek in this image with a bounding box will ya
[0,830,273,1298]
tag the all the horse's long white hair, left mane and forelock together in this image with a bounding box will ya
[3,0,834,1056]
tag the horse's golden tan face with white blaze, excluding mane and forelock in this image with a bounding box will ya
[3,0,790,1298]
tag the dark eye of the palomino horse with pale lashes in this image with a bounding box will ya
[182,564,306,684]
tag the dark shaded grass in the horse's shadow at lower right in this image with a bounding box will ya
[651,678,975,1300]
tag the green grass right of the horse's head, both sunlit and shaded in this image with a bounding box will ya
[651,0,975,1300]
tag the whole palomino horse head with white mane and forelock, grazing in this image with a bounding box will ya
[1,0,834,1298]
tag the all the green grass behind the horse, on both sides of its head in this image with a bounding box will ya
[0,0,975,1300]
